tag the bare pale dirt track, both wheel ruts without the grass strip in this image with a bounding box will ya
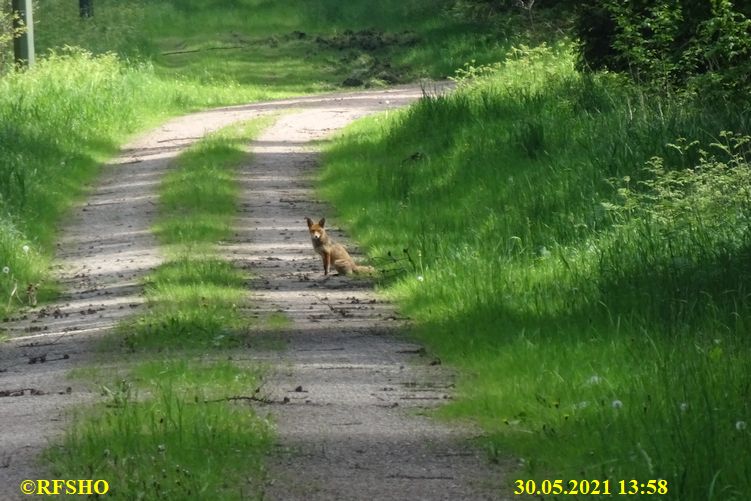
[0,86,503,500]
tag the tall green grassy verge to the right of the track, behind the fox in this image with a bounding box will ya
[321,46,751,500]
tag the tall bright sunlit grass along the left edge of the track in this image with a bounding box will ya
[0,49,276,313]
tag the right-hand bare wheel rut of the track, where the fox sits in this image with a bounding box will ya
[226,88,503,500]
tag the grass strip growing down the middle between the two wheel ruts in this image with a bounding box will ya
[48,119,278,499]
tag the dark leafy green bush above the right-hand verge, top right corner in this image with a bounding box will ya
[575,0,751,99]
